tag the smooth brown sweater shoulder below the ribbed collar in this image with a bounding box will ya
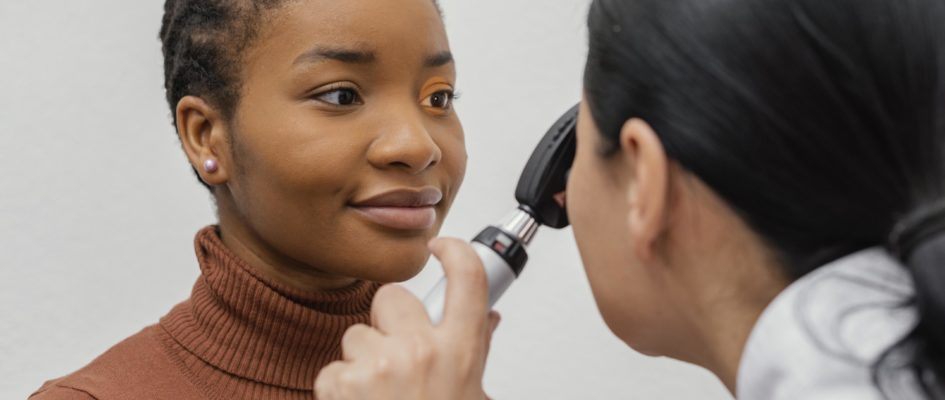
[30,325,203,400]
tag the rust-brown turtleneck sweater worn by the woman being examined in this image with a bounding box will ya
[30,227,379,400]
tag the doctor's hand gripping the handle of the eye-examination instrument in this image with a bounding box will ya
[315,239,499,400]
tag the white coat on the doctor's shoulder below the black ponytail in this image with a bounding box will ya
[736,248,924,400]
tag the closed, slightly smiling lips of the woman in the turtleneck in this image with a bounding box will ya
[351,187,443,230]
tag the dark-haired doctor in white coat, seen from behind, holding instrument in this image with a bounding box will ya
[315,0,945,400]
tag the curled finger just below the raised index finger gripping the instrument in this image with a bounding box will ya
[371,285,433,334]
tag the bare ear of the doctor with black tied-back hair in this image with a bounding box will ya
[620,118,669,260]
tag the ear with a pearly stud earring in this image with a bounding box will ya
[176,96,232,186]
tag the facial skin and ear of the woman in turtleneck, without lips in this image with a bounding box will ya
[177,0,466,291]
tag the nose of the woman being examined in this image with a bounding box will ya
[368,112,443,175]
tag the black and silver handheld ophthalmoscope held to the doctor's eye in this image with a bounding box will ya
[423,106,578,324]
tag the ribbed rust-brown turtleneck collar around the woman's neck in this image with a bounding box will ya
[161,226,379,390]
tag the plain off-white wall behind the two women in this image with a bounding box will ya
[0,0,731,400]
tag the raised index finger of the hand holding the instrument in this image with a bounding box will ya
[430,239,489,335]
